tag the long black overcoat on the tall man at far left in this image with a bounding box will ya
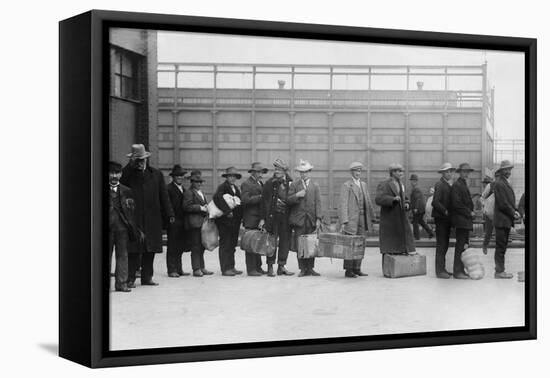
[120,164,174,253]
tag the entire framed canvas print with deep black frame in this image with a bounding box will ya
[59,10,536,367]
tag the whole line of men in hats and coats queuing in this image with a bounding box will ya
[109,144,528,292]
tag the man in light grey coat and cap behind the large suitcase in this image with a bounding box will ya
[338,162,374,278]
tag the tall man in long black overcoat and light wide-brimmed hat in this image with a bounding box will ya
[120,144,175,287]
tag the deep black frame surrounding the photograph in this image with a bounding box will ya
[59,10,537,368]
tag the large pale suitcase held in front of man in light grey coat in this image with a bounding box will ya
[316,233,366,260]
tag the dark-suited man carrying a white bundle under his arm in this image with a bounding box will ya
[212,167,242,276]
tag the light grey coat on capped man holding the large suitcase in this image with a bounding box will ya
[338,180,380,235]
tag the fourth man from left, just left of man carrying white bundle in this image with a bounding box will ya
[183,170,213,277]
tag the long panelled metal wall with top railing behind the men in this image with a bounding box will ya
[158,63,494,214]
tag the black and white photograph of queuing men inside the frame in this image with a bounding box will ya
[109,27,529,351]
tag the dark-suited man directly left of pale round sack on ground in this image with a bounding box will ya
[451,163,474,279]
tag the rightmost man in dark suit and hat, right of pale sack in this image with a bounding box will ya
[493,160,520,279]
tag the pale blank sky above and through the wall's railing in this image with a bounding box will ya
[158,32,525,139]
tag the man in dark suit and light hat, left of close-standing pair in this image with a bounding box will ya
[432,163,455,279]
